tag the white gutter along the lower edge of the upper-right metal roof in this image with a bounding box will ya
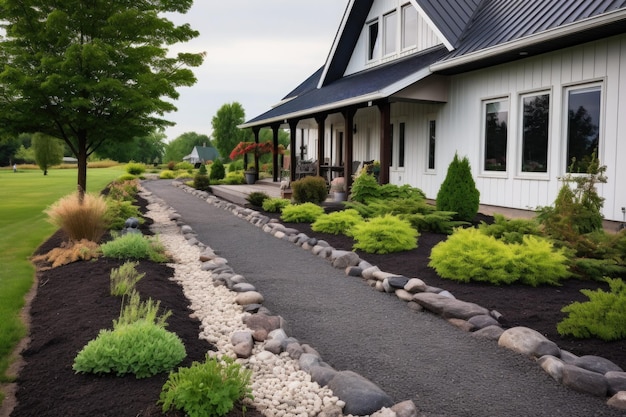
[430,9,626,72]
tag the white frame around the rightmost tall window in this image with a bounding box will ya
[561,80,606,175]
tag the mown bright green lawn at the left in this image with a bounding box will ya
[0,166,123,403]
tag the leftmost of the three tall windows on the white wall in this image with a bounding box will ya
[483,99,509,171]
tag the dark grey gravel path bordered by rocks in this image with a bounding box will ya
[143,180,624,417]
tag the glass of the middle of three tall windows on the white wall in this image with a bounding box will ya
[522,94,550,172]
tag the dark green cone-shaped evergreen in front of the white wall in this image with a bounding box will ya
[437,154,480,222]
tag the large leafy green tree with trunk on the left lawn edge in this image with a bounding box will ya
[0,0,204,192]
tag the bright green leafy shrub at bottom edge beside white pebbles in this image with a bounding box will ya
[159,355,253,417]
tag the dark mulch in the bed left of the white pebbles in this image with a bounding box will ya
[8,195,262,417]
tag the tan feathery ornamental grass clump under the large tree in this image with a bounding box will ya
[45,192,107,242]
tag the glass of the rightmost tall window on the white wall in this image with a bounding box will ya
[567,85,602,172]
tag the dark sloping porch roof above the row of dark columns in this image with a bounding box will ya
[241,47,447,124]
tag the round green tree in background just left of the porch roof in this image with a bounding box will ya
[211,102,252,157]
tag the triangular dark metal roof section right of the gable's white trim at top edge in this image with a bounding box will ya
[417,0,480,46]
